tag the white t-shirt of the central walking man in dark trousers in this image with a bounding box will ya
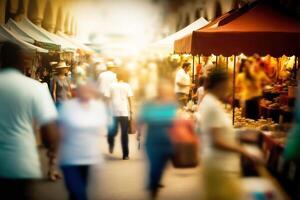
[105,82,133,117]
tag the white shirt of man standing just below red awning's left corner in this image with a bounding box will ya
[175,68,191,94]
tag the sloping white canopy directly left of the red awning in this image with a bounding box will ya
[149,17,208,53]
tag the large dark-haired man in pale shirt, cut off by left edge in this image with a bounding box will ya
[0,42,58,200]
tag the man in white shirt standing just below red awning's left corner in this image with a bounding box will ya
[175,63,194,106]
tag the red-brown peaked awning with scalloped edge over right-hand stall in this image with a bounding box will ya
[174,1,300,57]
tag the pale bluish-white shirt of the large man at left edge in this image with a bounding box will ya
[0,69,57,179]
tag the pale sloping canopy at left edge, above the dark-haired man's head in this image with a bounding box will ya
[0,26,48,53]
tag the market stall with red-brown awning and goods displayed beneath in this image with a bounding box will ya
[174,1,300,198]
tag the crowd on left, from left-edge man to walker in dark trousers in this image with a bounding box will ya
[0,42,133,200]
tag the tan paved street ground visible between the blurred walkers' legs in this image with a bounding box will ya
[34,135,200,200]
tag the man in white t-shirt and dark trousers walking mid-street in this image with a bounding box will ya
[104,71,133,160]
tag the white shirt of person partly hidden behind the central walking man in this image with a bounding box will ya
[98,71,117,95]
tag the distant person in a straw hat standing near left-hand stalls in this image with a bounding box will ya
[52,61,72,107]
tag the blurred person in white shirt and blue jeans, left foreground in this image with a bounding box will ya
[59,82,111,200]
